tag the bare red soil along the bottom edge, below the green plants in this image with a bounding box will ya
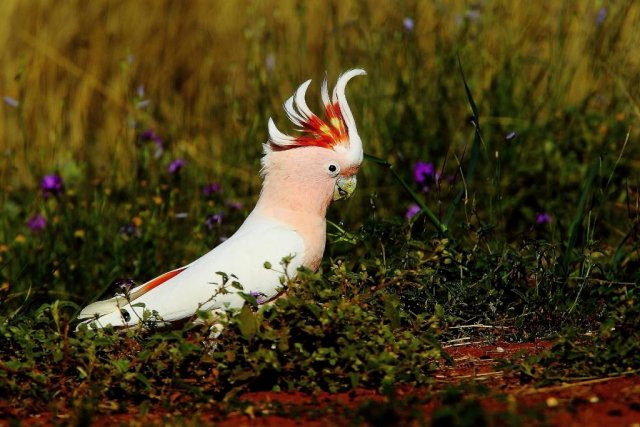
[5,342,640,427]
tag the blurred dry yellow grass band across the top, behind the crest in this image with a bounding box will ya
[0,0,640,188]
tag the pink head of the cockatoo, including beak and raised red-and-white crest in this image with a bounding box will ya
[262,69,366,203]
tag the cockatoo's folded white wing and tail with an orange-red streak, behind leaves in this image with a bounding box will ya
[78,219,305,326]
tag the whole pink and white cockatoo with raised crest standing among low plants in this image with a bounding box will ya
[78,69,366,328]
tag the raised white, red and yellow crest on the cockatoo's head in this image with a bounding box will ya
[269,69,366,159]
